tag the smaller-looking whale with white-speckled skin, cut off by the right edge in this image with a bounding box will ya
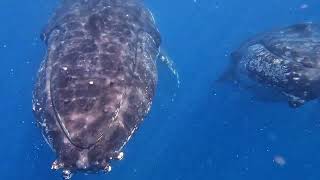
[226,23,320,107]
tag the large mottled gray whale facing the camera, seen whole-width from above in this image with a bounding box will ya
[33,0,160,176]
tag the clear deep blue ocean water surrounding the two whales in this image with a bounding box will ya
[0,0,320,180]
